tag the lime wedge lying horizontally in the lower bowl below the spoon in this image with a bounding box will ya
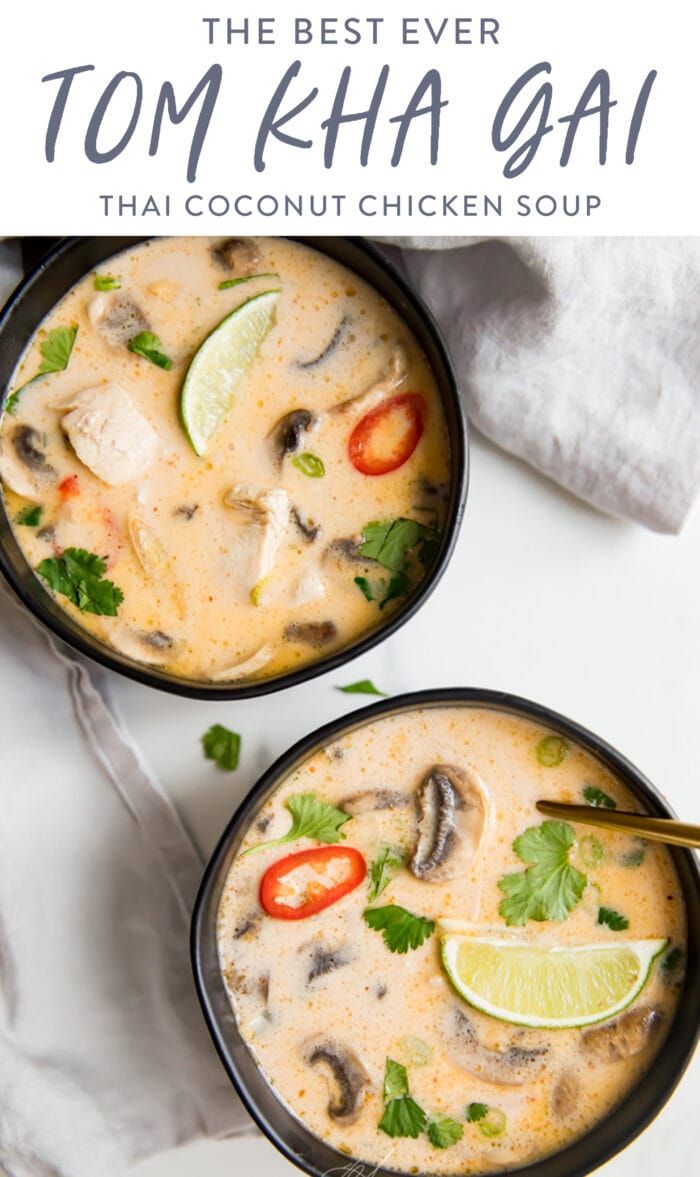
[440,933,666,1030]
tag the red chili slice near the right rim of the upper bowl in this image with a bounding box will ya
[348,392,426,474]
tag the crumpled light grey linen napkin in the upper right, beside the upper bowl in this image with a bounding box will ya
[387,237,700,532]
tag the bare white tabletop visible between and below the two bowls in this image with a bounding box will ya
[123,438,700,1177]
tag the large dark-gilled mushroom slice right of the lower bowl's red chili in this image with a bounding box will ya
[409,764,488,883]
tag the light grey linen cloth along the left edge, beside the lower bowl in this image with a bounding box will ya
[0,589,253,1177]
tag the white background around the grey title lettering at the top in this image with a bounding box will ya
[0,0,700,235]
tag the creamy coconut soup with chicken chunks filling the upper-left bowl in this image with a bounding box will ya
[0,238,449,681]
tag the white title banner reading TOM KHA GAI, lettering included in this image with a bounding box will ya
[0,0,700,235]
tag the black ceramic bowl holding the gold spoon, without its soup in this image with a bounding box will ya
[192,689,700,1177]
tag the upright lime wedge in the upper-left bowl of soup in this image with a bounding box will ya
[180,291,280,457]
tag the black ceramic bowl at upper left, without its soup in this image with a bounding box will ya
[0,237,468,699]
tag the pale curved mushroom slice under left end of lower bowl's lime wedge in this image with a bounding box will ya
[444,1009,548,1088]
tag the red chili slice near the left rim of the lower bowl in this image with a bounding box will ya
[260,846,367,919]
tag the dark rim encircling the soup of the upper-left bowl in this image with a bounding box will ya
[0,234,469,701]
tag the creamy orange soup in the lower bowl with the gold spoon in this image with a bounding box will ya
[218,706,685,1172]
